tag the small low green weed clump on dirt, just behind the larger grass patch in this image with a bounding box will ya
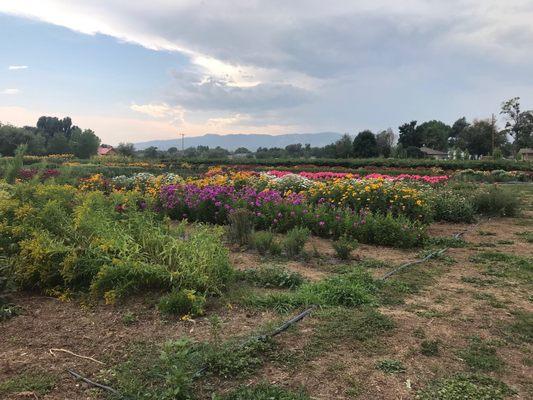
[241,265,304,289]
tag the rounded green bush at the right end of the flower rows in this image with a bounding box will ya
[473,186,520,217]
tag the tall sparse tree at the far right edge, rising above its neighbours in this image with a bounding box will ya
[500,97,533,151]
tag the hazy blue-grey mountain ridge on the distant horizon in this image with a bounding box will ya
[135,132,342,151]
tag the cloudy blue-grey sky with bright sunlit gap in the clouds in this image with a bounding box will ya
[0,0,533,144]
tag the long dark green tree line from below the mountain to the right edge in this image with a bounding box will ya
[117,97,533,159]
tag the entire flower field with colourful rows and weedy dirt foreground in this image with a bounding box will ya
[0,161,533,400]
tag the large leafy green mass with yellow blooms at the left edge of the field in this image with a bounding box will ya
[0,184,233,302]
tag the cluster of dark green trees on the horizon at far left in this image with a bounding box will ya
[0,116,100,158]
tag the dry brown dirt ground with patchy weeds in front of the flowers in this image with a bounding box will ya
[0,215,533,400]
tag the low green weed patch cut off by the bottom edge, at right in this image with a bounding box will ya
[416,374,514,400]
